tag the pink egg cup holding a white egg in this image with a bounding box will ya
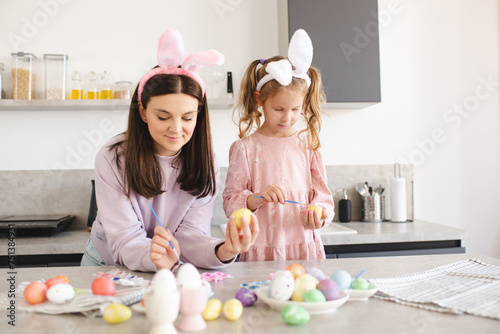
[177,281,210,332]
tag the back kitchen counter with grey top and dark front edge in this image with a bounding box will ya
[0,220,467,266]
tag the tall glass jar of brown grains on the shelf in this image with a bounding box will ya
[11,52,37,100]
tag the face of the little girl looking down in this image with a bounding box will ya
[255,90,304,137]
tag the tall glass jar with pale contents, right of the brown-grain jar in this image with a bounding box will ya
[43,54,68,100]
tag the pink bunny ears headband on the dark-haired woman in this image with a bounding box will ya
[137,29,224,102]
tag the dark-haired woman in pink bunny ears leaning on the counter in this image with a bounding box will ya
[82,30,259,271]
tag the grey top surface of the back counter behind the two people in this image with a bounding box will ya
[0,220,466,255]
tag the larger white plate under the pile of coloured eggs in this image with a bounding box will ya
[255,284,349,314]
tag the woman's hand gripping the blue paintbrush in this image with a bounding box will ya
[149,226,181,270]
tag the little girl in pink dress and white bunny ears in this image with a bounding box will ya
[223,30,334,261]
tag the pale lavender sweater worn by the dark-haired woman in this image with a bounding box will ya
[92,135,227,271]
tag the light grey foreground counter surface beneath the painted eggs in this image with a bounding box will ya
[0,254,500,334]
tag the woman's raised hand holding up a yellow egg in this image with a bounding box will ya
[216,215,259,262]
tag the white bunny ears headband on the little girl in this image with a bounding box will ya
[256,29,313,92]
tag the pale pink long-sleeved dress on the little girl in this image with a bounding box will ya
[222,132,334,261]
